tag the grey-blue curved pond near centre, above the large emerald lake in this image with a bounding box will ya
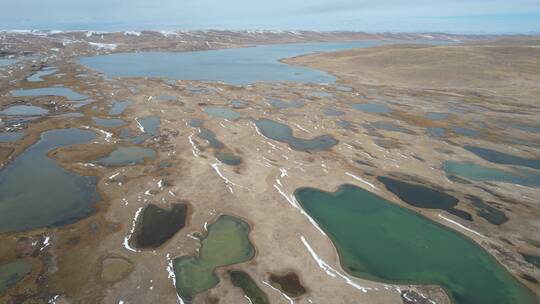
[254,118,338,151]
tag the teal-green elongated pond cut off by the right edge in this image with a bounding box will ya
[443,161,540,188]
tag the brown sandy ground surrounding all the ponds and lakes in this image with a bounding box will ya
[0,33,540,303]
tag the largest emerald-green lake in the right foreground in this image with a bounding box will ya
[295,185,538,304]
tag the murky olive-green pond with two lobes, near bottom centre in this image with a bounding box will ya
[173,215,255,302]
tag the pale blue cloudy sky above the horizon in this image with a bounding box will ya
[0,0,540,34]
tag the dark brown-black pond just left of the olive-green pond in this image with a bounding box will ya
[133,204,188,248]
